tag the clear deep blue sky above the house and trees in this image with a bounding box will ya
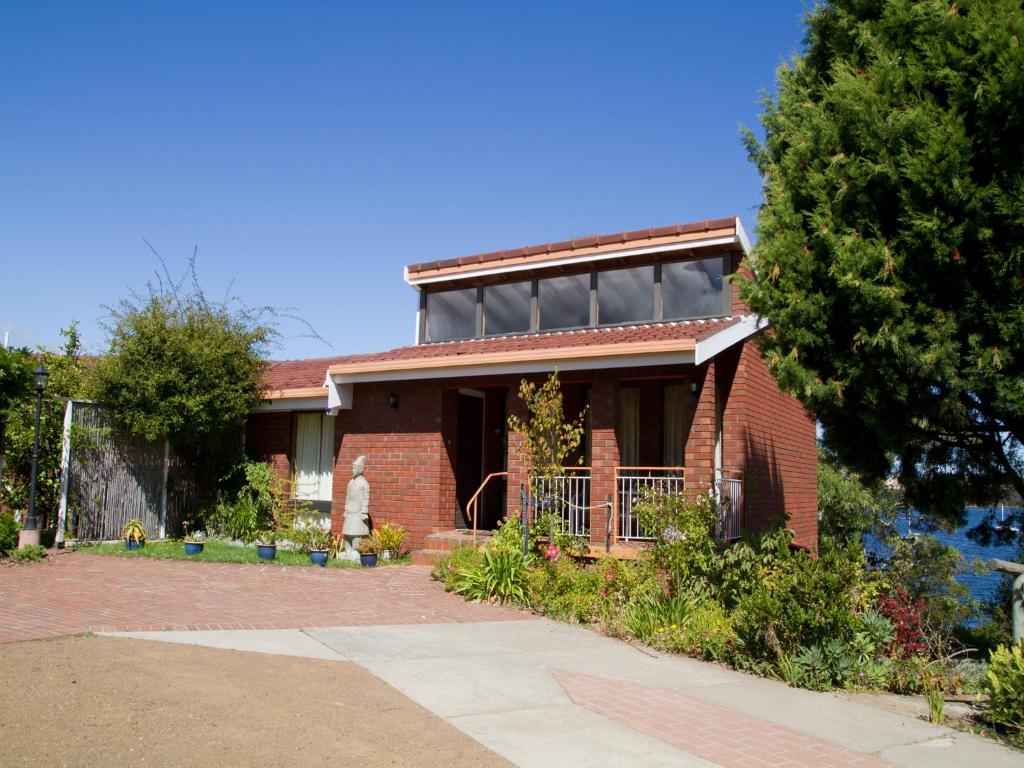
[0,0,808,358]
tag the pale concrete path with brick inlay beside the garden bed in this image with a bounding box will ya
[105,618,1024,768]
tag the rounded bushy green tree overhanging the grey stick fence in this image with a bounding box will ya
[91,255,276,445]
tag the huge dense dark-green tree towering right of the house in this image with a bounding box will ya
[742,0,1024,524]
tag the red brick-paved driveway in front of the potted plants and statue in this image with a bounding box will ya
[0,553,528,643]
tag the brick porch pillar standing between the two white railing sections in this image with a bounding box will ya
[590,377,618,547]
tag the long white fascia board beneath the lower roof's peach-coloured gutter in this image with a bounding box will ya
[328,351,693,387]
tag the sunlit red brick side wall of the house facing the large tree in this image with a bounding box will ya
[719,341,818,549]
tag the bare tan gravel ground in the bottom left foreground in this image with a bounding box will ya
[0,637,510,768]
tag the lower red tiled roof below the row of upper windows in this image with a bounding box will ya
[266,315,742,389]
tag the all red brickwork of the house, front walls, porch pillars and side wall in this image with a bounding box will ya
[241,343,817,548]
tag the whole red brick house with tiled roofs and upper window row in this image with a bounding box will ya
[246,218,817,561]
